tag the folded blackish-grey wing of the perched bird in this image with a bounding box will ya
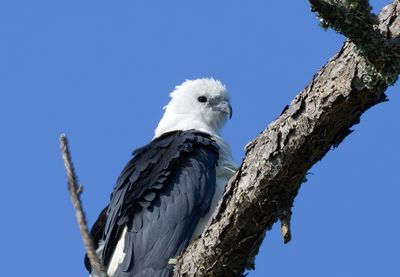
[86,130,218,277]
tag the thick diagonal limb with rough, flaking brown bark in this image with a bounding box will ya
[174,1,400,276]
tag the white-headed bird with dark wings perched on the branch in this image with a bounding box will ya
[85,78,236,277]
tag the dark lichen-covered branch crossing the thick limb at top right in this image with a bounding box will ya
[309,0,400,87]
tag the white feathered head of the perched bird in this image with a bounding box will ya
[155,78,232,137]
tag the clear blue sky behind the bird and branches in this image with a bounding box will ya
[0,0,400,277]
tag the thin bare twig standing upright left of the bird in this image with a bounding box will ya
[60,134,107,277]
